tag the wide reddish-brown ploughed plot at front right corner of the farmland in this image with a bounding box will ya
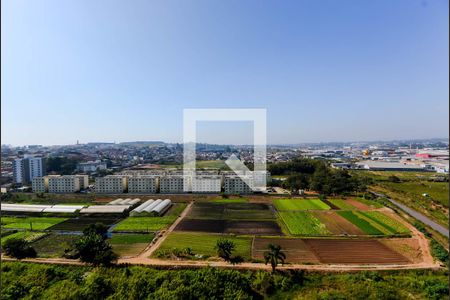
[304,239,410,264]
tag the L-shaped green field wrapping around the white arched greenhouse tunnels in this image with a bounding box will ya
[113,203,187,232]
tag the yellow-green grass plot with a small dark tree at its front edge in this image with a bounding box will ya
[156,232,252,260]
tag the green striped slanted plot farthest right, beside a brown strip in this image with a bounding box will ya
[337,211,409,235]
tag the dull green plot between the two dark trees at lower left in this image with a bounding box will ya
[32,233,81,257]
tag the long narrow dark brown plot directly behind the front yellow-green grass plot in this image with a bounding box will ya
[175,219,282,235]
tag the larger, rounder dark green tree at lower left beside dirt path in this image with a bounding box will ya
[75,232,117,266]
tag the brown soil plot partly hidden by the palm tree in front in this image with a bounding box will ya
[252,238,319,263]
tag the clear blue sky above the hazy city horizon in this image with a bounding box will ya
[1,0,449,145]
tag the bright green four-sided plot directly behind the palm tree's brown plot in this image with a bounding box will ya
[279,211,331,236]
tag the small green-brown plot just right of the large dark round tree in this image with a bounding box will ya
[109,233,154,257]
